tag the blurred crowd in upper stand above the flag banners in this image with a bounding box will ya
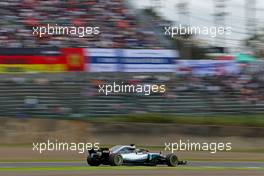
[0,0,160,49]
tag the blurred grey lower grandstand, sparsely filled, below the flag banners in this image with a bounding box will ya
[0,64,264,118]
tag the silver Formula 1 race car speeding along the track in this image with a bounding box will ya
[87,145,187,167]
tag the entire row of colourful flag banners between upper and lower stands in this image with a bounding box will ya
[0,48,240,73]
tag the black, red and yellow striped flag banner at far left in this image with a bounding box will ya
[0,48,66,73]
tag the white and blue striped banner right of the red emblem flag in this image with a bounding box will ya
[85,48,178,72]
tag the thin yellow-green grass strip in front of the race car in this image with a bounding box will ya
[0,166,264,172]
